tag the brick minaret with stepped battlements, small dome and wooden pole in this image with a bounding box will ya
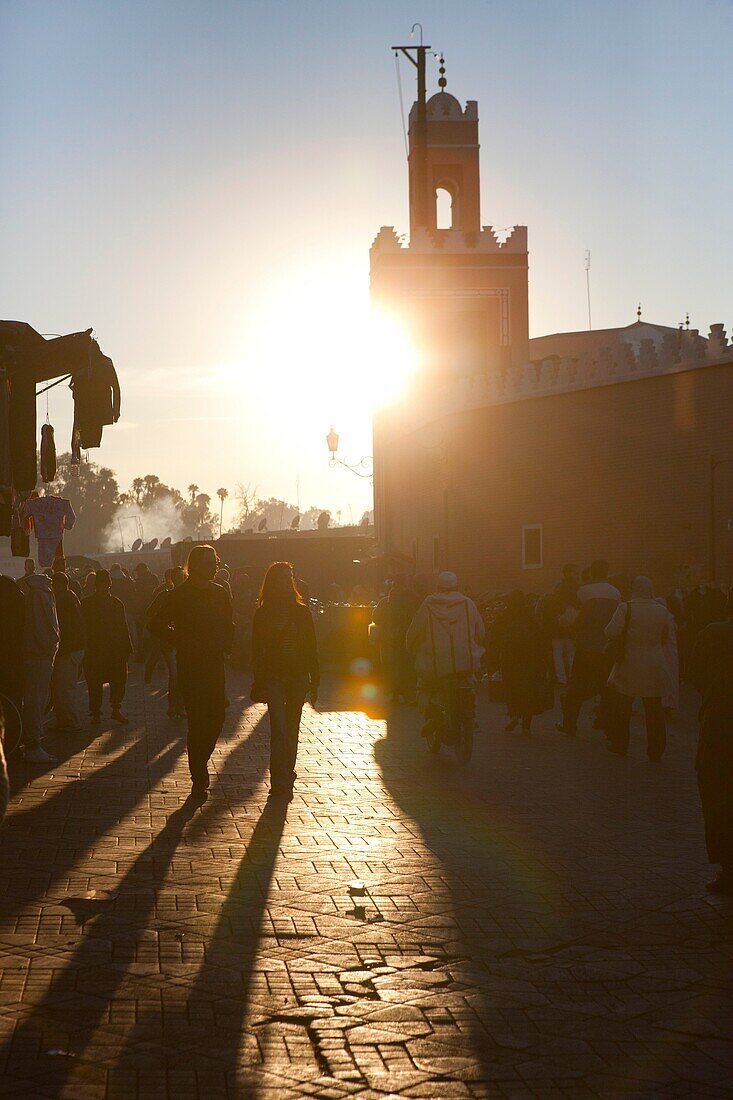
[370,46,528,386]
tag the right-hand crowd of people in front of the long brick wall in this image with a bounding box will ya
[372,560,733,893]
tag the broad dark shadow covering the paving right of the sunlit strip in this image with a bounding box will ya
[375,699,733,1097]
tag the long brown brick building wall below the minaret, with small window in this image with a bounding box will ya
[375,364,733,591]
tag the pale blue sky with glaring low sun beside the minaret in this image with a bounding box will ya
[0,0,733,527]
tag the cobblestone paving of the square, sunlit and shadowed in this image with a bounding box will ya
[0,666,733,1100]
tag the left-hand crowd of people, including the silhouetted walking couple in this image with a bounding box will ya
[0,554,319,802]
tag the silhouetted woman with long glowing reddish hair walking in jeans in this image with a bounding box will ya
[252,561,320,801]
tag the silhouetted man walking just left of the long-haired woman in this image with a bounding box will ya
[151,546,233,802]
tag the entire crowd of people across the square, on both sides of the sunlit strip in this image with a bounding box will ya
[0,546,733,892]
